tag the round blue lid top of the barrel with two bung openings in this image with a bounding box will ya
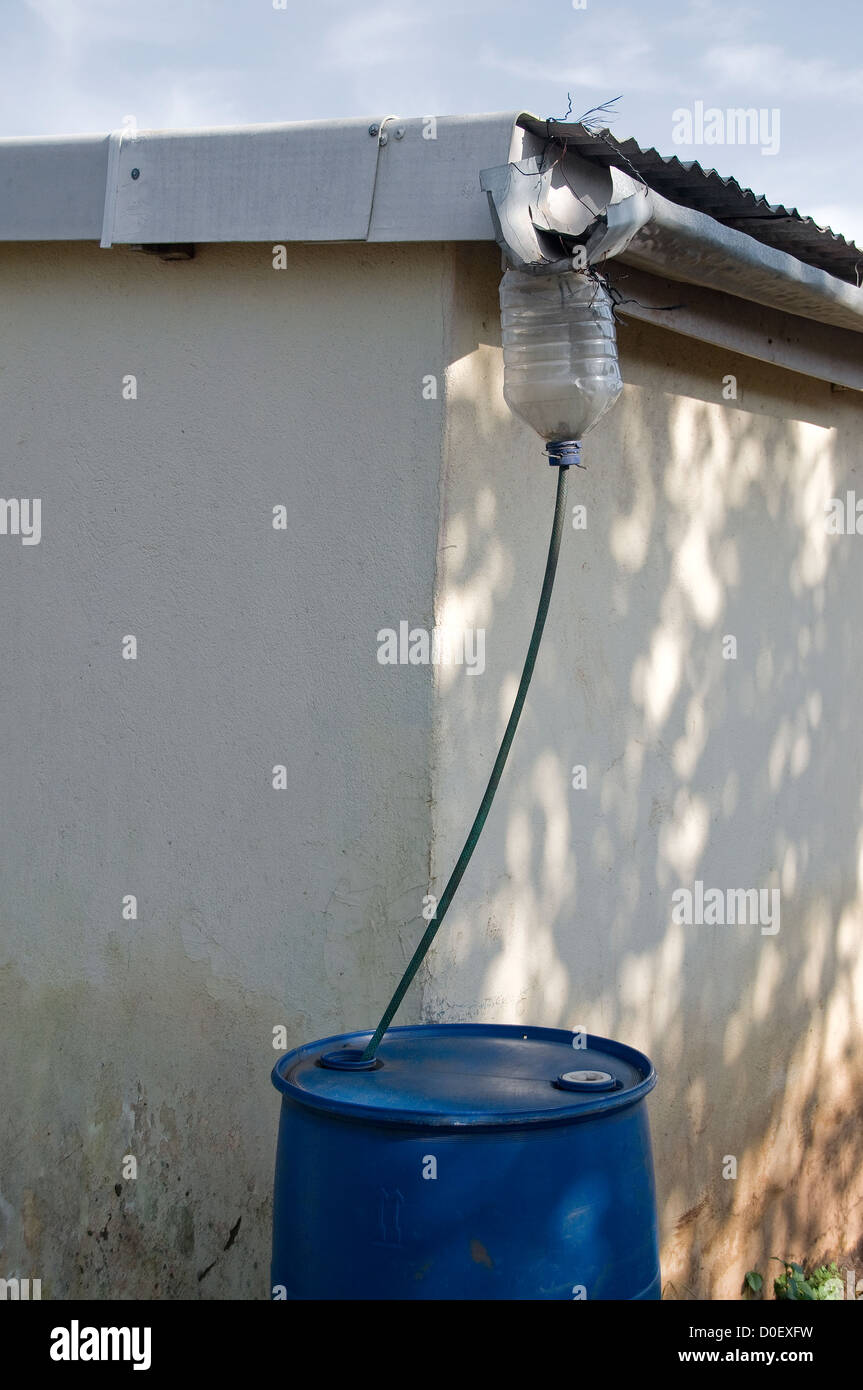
[272,1023,656,1129]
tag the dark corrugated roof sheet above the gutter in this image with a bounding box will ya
[521,117,863,285]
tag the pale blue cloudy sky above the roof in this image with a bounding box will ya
[6,0,863,245]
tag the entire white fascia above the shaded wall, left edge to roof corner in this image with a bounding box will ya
[0,111,517,246]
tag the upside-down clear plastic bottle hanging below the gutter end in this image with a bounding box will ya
[500,270,623,441]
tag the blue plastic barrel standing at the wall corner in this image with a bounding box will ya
[271,1024,660,1300]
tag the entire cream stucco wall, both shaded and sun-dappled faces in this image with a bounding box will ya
[0,236,863,1297]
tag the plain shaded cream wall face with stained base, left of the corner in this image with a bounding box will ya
[0,246,445,1298]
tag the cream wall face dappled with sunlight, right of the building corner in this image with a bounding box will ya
[424,249,863,1298]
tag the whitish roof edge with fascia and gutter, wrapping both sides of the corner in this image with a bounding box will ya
[0,111,863,389]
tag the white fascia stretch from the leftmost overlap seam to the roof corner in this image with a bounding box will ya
[106,113,514,243]
